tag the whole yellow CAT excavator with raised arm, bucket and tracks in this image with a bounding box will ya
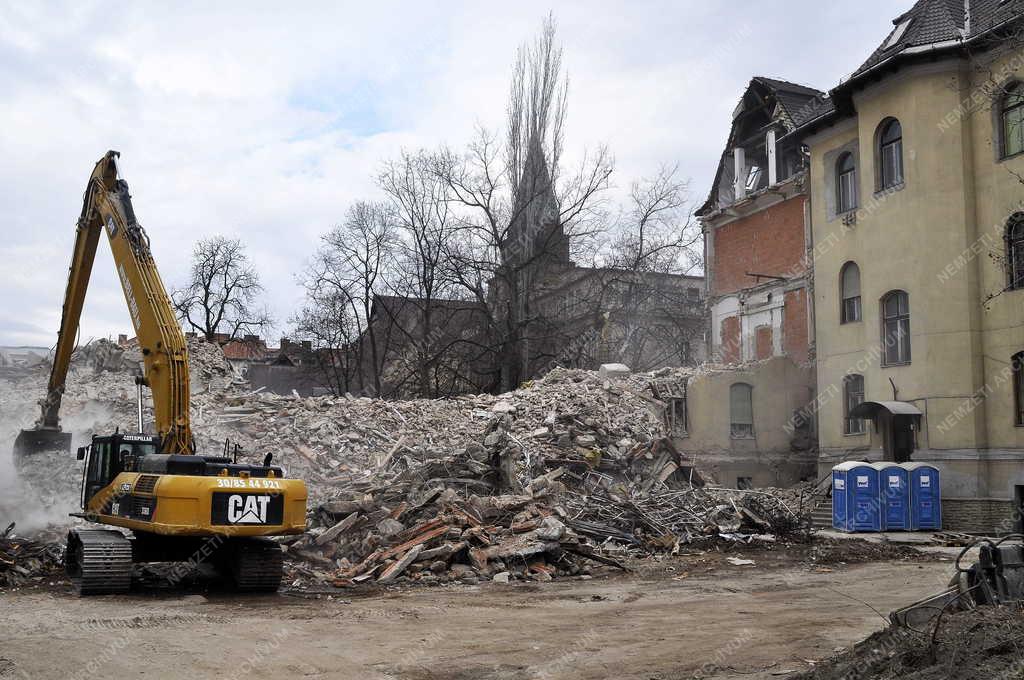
[14,152,306,595]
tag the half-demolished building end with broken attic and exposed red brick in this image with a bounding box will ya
[680,77,823,485]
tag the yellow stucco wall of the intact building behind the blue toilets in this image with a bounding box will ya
[807,51,1024,510]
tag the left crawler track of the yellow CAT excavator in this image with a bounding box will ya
[65,528,132,596]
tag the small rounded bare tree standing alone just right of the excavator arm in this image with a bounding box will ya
[171,236,271,340]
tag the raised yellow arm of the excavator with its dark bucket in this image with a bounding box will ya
[14,151,195,456]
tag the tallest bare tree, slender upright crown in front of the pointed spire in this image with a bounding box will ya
[433,16,612,389]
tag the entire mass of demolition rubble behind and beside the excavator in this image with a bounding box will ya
[0,339,809,586]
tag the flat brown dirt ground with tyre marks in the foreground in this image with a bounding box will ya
[0,554,950,680]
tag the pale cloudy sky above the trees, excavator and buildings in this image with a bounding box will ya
[0,0,912,346]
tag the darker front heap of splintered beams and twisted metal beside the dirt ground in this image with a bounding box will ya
[286,411,809,586]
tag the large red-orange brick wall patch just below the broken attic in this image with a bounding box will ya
[711,196,805,296]
